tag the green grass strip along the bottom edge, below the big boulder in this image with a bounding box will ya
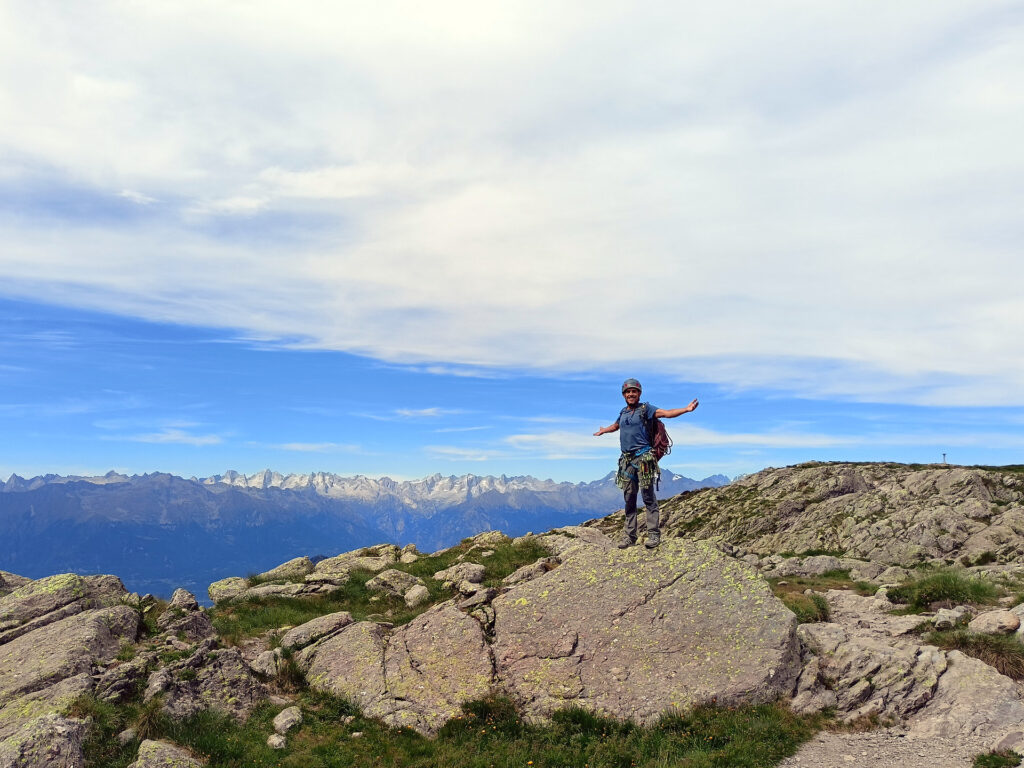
[75,691,824,768]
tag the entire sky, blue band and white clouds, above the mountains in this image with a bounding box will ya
[0,0,1024,480]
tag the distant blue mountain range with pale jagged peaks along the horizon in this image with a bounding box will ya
[0,470,729,595]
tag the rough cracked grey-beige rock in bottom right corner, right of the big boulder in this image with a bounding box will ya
[780,590,1024,768]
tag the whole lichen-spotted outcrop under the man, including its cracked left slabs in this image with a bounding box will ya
[297,529,800,733]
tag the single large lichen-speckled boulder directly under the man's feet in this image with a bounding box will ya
[492,540,800,723]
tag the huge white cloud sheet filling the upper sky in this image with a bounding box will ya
[0,0,1024,404]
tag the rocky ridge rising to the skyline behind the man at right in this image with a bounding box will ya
[597,463,1024,566]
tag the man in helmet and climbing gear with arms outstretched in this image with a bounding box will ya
[594,379,698,549]
